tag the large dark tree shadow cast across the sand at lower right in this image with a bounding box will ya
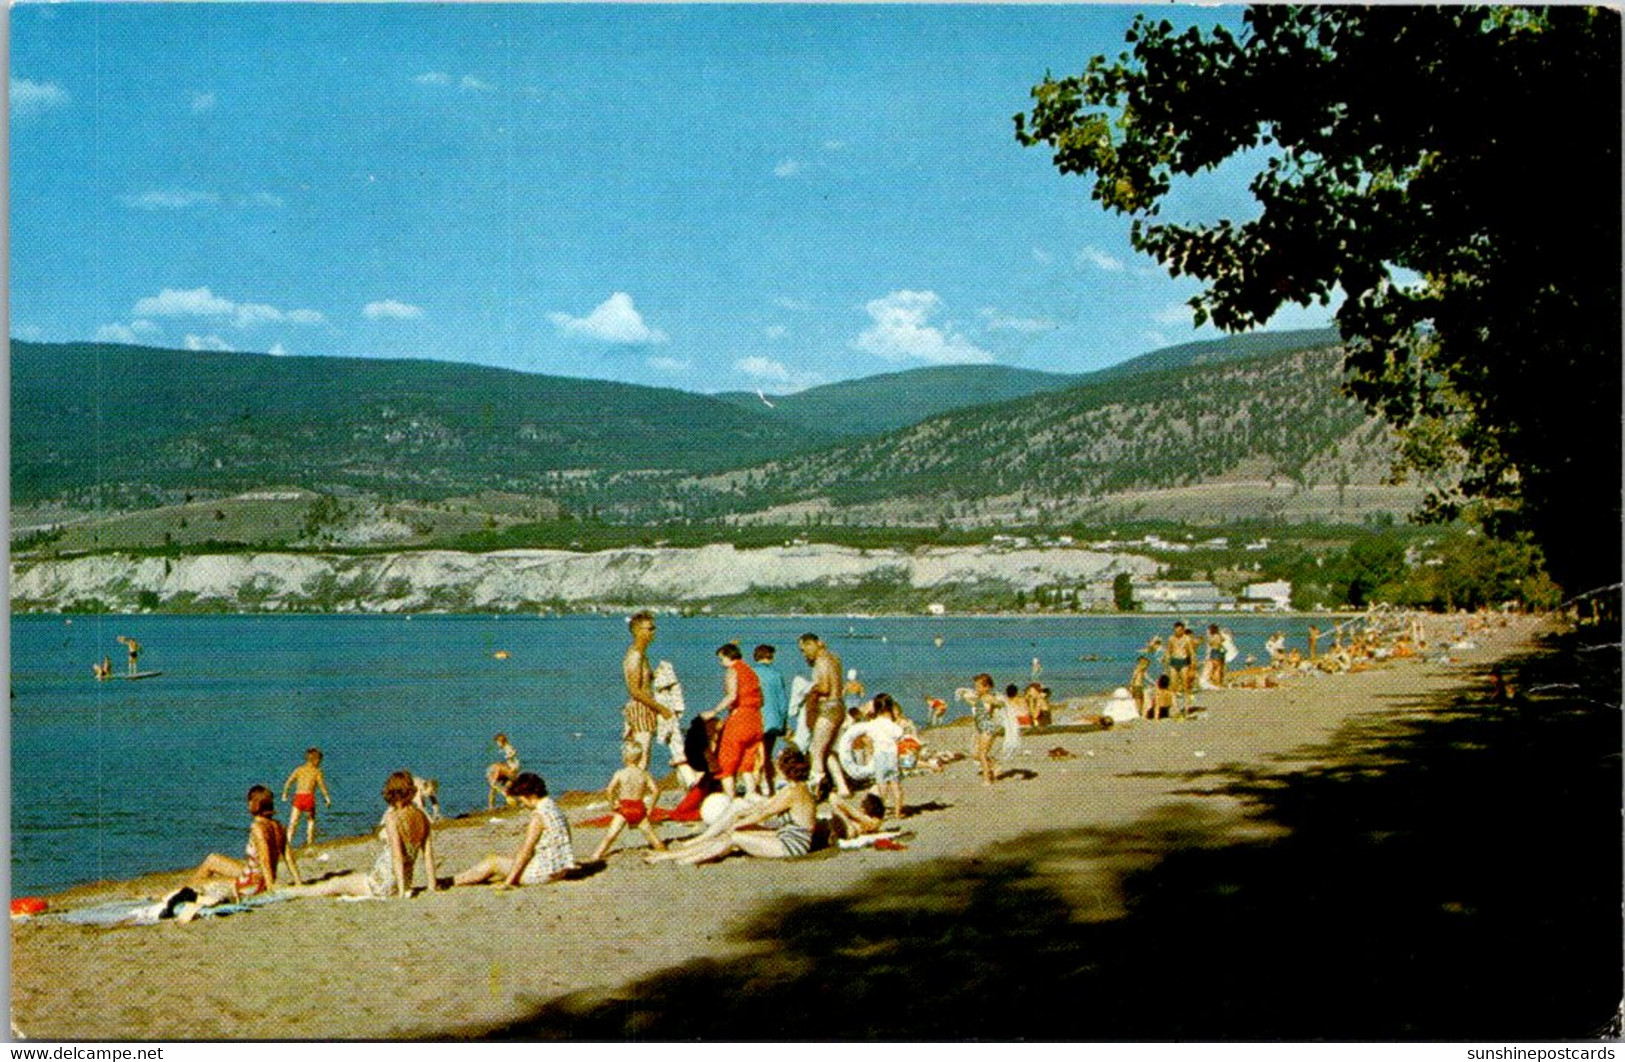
[465,626,1622,1043]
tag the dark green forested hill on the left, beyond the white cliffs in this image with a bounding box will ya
[11,341,826,502]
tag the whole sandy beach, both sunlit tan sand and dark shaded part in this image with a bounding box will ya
[11,619,1620,1039]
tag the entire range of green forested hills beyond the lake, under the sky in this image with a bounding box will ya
[11,330,1414,542]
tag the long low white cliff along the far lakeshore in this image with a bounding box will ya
[11,546,1159,612]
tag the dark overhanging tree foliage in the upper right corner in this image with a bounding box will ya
[1016,5,1620,593]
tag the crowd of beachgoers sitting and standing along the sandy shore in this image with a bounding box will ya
[85,609,1515,921]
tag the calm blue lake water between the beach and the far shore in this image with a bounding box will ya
[11,615,1324,895]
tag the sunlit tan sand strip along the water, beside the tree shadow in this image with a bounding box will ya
[11,619,1560,1039]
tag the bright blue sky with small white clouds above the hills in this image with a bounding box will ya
[10,3,1331,393]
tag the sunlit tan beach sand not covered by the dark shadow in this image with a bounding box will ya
[13,620,1619,1039]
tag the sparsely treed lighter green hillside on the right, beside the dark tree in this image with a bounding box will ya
[666,346,1393,518]
